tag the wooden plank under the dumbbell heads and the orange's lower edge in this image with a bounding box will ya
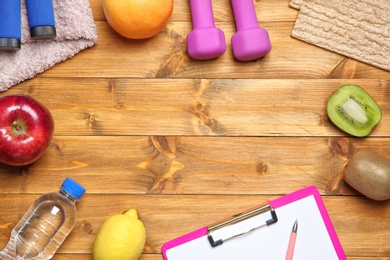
[35,22,390,79]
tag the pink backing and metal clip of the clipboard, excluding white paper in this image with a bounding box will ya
[162,186,347,260]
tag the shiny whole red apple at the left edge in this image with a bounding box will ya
[0,95,54,166]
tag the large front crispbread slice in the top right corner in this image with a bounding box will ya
[291,0,390,71]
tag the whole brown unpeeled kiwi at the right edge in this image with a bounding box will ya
[344,150,390,200]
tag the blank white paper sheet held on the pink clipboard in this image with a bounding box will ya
[166,195,338,260]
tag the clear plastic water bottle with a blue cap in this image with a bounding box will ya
[0,178,85,260]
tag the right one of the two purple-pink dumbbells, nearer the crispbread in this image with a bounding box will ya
[231,0,271,61]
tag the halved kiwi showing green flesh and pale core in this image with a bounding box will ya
[326,85,382,137]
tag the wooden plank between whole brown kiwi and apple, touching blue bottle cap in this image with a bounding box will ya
[0,136,390,195]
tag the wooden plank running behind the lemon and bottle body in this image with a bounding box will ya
[0,194,390,257]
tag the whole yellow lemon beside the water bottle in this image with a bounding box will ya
[93,209,146,260]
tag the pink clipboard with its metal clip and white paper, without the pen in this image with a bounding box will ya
[162,186,347,260]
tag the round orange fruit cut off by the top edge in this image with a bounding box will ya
[102,0,173,39]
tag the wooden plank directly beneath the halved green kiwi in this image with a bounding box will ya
[0,78,390,137]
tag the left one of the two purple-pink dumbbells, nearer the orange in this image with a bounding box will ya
[187,0,226,60]
